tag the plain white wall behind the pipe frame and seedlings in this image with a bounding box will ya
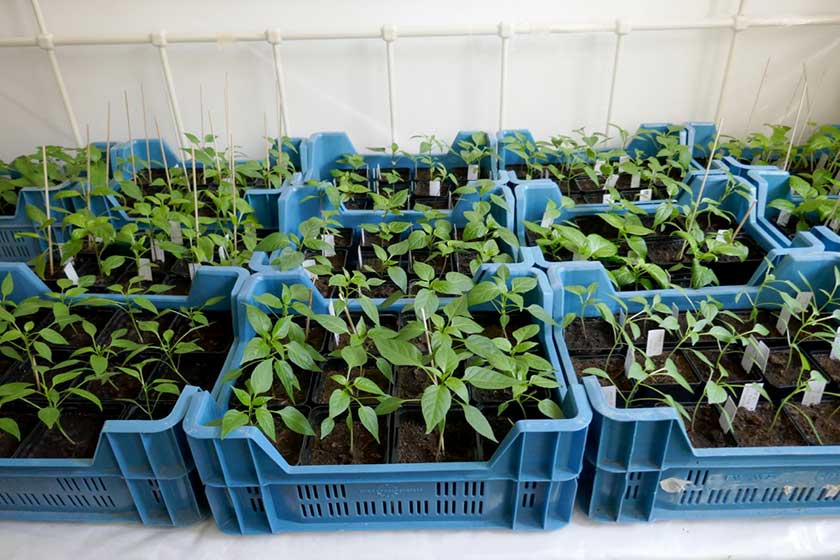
[0,0,840,158]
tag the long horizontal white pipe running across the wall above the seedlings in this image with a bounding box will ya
[0,15,840,48]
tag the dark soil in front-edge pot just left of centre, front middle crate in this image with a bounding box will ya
[301,411,388,465]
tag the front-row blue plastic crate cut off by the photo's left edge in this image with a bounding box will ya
[0,263,248,526]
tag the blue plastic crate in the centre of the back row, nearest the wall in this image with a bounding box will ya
[301,131,498,181]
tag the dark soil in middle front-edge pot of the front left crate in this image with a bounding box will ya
[18,409,122,459]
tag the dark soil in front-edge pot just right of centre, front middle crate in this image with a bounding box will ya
[393,412,478,463]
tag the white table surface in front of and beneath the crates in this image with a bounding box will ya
[0,512,840,560]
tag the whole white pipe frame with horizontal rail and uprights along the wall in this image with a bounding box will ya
[9,0,840,146]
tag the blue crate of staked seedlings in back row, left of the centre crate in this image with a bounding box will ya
[82,138,303,230]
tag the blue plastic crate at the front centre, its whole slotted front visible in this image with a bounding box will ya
[184,266,590,534]
